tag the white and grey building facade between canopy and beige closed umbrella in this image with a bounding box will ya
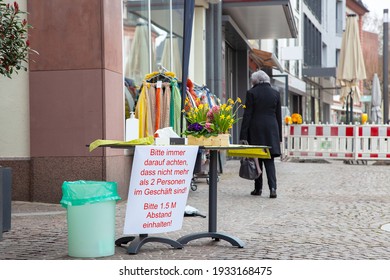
[292,0,345,123]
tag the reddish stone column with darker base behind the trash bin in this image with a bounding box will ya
[28,0,129,202]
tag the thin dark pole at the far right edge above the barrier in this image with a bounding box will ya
[383,9,389,124]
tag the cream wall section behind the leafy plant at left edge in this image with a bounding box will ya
[0,0,30,159]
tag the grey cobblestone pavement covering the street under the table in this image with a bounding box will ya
[0,160,390,260]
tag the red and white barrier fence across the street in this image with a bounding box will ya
[282,124,390,160]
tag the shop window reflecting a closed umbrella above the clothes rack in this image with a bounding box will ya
[123,0,184,86]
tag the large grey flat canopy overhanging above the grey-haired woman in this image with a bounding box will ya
[222,0,298,39]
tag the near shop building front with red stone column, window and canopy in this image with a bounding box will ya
[0,0,296,203]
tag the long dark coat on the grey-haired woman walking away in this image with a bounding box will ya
[240,83,282,157]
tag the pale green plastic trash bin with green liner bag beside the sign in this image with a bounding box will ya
[61,181,120,258]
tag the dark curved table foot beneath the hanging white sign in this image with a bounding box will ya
[115,234,183,254]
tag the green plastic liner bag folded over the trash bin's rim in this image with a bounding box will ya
[60,180,121,208]
